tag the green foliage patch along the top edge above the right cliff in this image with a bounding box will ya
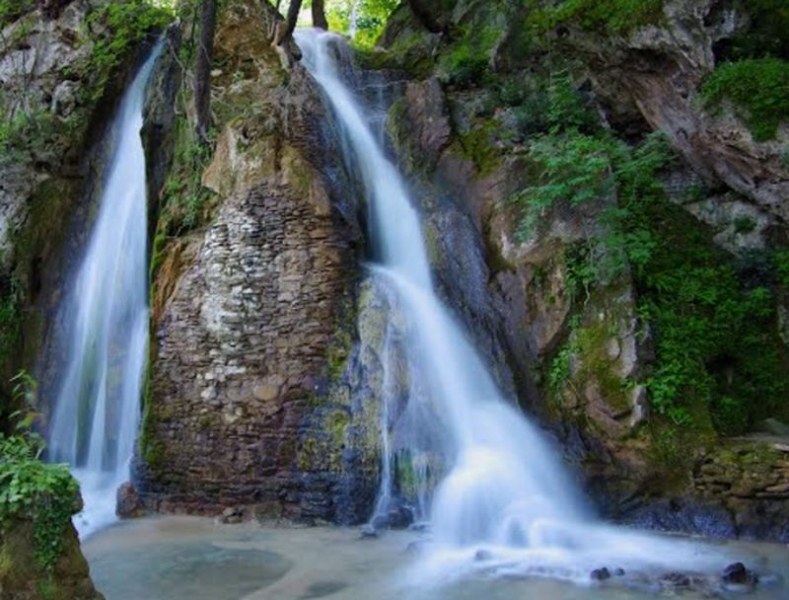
[529,0,663,35]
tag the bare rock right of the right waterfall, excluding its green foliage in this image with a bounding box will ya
[376,0,789,540]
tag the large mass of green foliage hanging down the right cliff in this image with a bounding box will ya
[514,98,789,434]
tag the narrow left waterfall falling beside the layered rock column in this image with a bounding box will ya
[48,42,162,537]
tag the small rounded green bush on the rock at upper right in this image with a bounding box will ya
[699,58,789,141]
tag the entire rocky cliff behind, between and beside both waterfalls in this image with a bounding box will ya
[0,0,789,552]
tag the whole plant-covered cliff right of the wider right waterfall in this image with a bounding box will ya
[370,0,789,539]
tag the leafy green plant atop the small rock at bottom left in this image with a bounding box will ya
[0,372,79,570]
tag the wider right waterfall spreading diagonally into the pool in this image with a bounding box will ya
[296,30,740,584]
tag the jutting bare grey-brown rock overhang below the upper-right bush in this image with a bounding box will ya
[568,0,789,227]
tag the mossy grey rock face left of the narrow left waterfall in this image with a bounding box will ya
[0,0,172,400]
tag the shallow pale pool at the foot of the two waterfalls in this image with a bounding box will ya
[83,517,789,600]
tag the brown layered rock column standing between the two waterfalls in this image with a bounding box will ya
[137,0,368,520]
